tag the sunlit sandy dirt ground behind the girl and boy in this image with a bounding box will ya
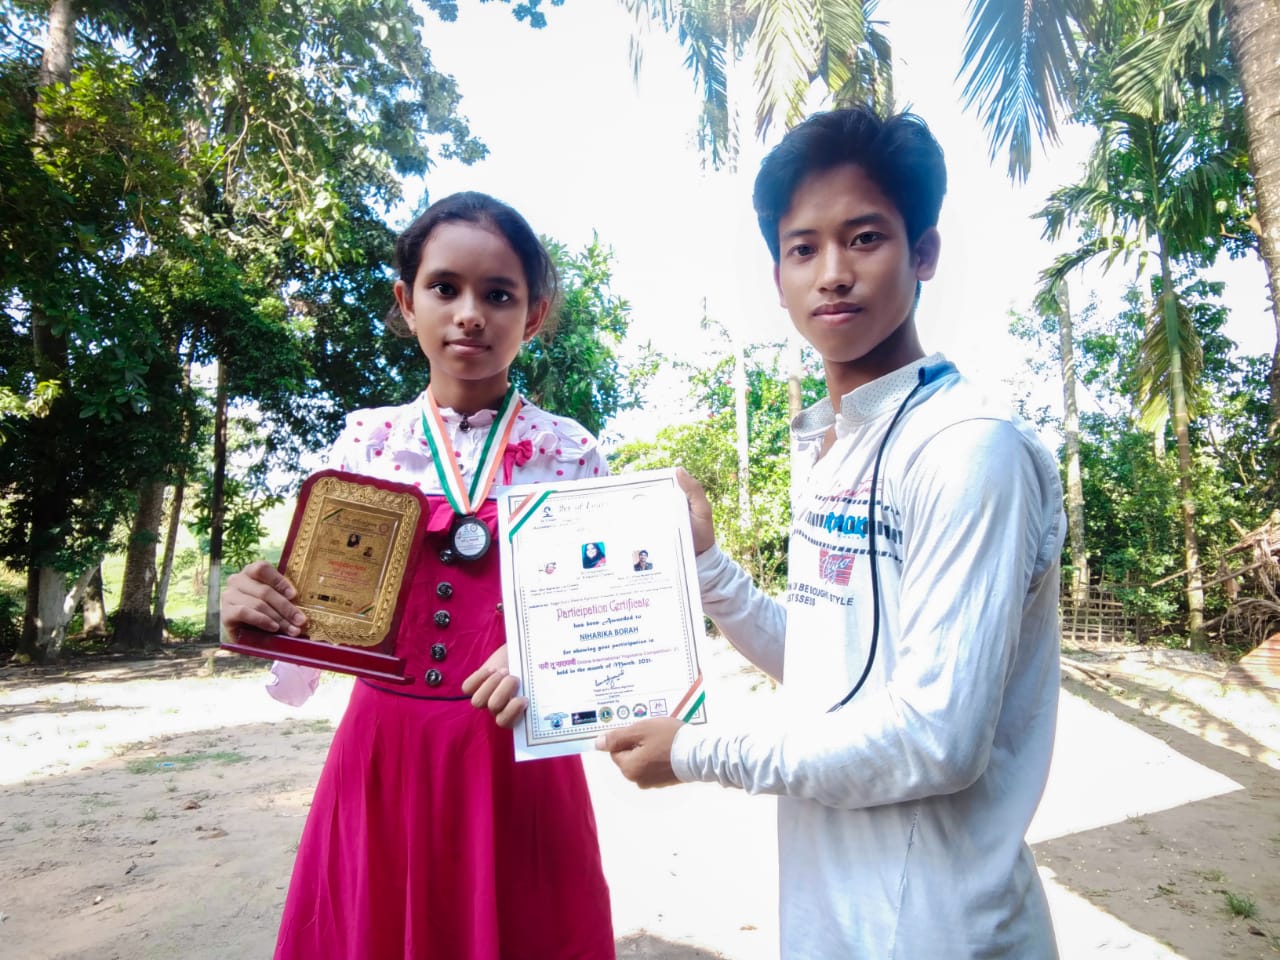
[0,646,1280,960]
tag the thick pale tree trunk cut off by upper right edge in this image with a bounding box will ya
[1224,0,1280,439]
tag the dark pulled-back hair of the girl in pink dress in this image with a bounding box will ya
[387,191,559,337]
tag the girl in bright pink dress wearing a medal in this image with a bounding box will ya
[223,193,614,960]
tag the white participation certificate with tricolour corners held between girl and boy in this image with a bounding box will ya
[498,470,707,760]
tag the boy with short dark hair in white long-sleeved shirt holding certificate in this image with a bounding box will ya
[598,110,1064,960]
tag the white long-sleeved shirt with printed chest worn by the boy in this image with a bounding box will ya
[672,356,1065,960]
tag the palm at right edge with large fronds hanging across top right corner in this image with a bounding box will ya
[961,0,1280,434]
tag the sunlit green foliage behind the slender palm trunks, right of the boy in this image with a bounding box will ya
[1015,276,1276,643]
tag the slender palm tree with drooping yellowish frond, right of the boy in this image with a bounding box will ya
[1039,106,1244,648]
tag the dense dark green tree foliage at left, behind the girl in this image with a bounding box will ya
[0,0,562,655]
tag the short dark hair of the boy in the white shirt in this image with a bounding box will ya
[751,106,947,264]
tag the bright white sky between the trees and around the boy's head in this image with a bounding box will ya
[409,0,1274,433]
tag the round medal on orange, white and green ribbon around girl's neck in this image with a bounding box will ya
[422,387,524,561]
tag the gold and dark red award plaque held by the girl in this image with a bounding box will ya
[223,470,426,684]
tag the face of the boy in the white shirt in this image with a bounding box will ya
[773,165,940,389]
